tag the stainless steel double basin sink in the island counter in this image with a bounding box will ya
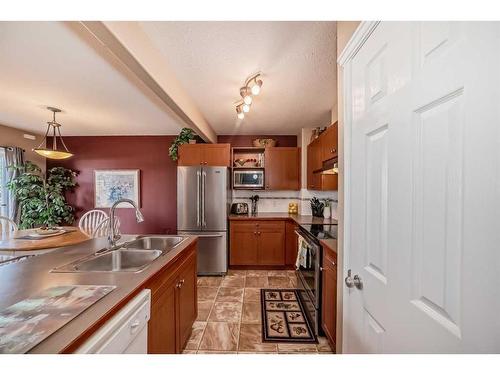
[52,236,186,272]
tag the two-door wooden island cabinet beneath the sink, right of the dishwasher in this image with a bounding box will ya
[146,242,198,354]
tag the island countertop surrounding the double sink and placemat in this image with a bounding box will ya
[0,235,197,353]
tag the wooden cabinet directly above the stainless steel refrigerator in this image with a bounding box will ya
[177,143,231,167]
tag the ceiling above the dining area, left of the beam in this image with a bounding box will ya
[0,22,184,136]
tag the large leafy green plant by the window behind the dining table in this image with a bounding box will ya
[7,161,76,229]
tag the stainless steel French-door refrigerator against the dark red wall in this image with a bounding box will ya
[177,167,231,275]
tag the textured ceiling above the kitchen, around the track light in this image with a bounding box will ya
[141,22,337,134]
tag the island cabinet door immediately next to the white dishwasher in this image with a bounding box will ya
[148,280,177,354]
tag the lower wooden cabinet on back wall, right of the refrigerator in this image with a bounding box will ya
[229,220,285,266]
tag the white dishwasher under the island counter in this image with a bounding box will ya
[75,289,151,354]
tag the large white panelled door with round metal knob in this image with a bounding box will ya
[340,22,500,353]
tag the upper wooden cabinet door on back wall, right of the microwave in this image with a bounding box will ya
[264,147,300,190]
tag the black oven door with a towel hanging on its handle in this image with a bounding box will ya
[296,232,321,309]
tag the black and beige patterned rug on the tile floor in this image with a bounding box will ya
[260,289,317,343]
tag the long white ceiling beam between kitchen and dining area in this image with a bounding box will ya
[81,21,217,143]
